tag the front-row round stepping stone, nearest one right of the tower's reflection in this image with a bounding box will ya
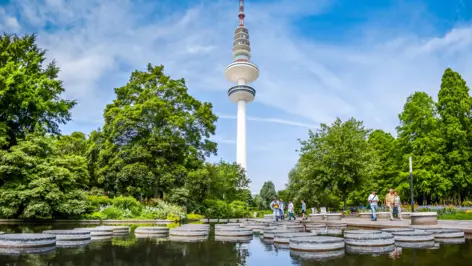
[289,236,344,252]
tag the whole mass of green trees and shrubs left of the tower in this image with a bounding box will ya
[0,34,252,220]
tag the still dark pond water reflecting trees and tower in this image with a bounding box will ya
[0,225,472,266]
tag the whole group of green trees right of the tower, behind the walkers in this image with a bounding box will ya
[283,69,472,209]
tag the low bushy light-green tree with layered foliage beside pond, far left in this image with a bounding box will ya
[0,129,88,218]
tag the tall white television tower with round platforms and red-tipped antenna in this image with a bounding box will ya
[225,0,259,169]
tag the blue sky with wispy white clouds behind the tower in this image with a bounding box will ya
[0,0,472,192]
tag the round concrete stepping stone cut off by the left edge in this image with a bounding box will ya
[0,234,56,255]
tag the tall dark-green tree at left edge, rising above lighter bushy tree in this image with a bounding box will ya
[0,34,76,149]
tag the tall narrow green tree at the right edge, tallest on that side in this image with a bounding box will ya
[437,68,472,204]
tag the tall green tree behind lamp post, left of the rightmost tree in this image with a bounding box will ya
[395,92,451,203]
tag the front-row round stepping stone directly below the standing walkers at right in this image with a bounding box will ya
[344,232,395,254]
